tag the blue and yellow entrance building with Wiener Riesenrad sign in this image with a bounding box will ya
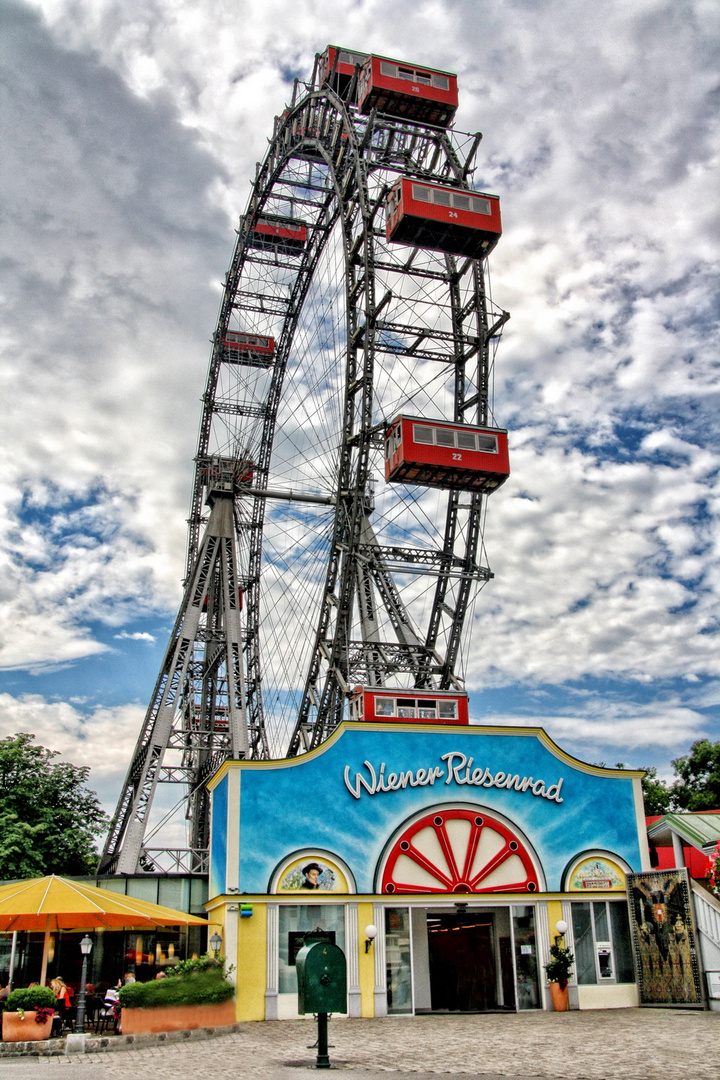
[207,719,649,1020]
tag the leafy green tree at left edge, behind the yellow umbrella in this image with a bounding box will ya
[0,732,109,880]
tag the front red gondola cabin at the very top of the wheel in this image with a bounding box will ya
[357,56,458,127]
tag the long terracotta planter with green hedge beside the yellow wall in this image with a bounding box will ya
[120,956,235,1035]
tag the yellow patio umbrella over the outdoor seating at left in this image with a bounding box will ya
[0,874,207,983]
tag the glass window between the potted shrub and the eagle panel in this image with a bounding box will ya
[572,900,635,986]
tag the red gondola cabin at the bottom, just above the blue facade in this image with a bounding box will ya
[350,686,470,724]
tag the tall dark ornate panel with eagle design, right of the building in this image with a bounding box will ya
[627,869,703,1007]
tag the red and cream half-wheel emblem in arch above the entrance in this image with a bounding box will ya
[381,809,538,893]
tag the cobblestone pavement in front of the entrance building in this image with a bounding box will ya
[0,1009,720,1080]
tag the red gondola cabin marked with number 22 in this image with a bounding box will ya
[385,416,510,495]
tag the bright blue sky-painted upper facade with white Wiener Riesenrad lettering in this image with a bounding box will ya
[213,725,641,893]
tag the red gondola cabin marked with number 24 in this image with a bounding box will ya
[385,177,502,259]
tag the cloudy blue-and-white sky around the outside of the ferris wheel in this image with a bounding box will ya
[0,0,720,809]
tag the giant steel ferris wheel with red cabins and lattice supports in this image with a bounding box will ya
[100,48,508,873]
